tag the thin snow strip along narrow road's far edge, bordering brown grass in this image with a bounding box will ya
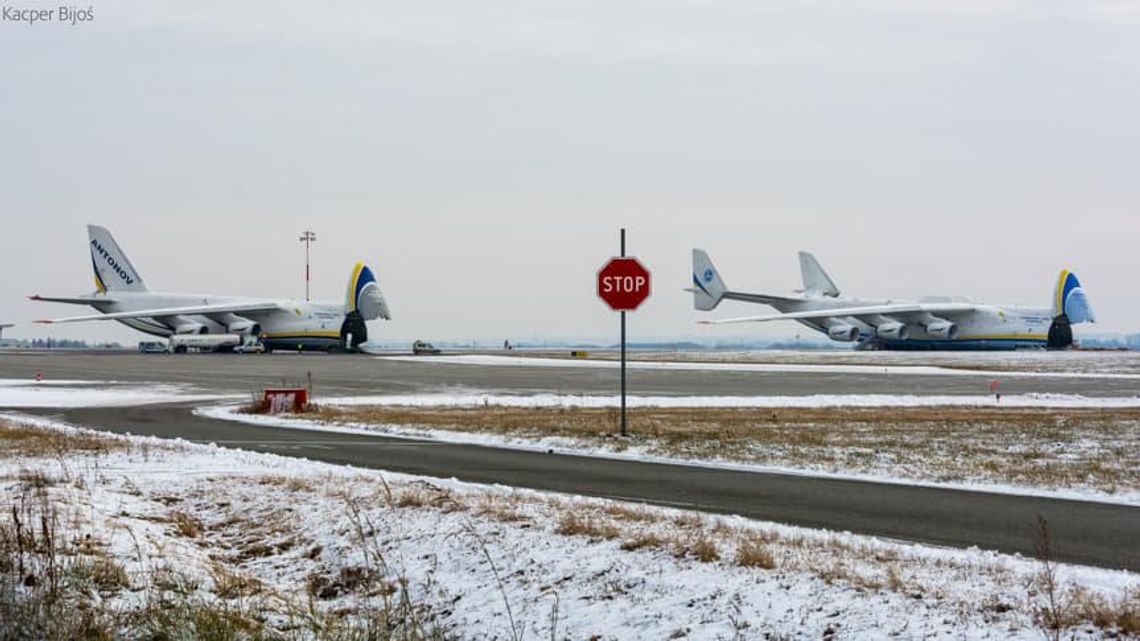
[194,400,1140,505]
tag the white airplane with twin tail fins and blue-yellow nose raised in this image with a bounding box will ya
[687,249,1096,349]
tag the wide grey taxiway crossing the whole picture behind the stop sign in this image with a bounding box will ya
[0,351,1140,398]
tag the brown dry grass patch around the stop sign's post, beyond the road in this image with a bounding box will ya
[316,406,1140,493]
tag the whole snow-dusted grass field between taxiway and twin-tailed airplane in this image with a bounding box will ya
[376,351,1140,381]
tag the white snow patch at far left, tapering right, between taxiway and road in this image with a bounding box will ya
[0,379,234,407]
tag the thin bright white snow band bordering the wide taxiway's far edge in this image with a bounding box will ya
[376,352,1140,380]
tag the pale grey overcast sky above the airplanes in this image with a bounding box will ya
[0,0,1140,340]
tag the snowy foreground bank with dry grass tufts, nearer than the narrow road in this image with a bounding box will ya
[0,416,1140,640]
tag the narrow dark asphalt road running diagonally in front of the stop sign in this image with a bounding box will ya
[26,405,1140,571]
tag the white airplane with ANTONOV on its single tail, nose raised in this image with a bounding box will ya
[31,225,391,351]
